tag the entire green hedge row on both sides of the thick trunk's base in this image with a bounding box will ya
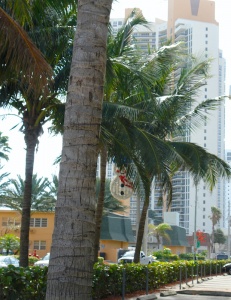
[0,261,227,300]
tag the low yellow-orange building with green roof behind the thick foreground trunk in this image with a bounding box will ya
[0,209,134,262]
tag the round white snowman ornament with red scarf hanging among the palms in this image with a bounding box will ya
[110,168,133,200]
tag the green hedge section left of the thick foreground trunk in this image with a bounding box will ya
[0,266,47,300]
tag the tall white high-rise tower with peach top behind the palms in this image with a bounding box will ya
[109,0,227,235]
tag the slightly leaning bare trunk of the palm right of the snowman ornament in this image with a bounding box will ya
[134,193,150,263]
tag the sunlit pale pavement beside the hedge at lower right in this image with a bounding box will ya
[125,274,231,300]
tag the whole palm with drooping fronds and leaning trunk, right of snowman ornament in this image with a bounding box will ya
[101,41,230,261]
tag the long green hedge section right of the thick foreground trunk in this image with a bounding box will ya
[92,260,227,299]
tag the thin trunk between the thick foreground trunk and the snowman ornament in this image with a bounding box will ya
[94,147,107,262]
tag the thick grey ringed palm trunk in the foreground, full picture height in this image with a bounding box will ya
[46,0,112,300]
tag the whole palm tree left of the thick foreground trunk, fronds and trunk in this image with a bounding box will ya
[0,0,76,266]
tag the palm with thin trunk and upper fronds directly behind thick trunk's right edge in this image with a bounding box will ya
[94,10,147,262]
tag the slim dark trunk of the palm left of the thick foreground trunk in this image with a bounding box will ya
[20,130,38,267]
